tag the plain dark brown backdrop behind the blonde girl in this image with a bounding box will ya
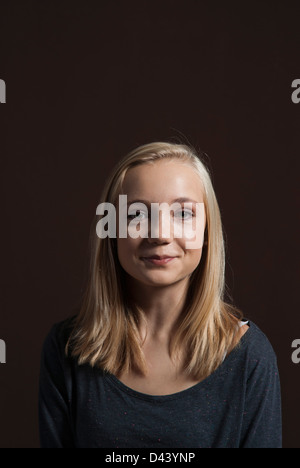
[0,0,300,448]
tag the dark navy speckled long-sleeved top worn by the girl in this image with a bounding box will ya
[39,320,282,448]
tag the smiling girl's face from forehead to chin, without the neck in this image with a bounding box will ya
[117,159,205,286]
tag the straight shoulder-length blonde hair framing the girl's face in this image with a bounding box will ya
[66,142,242,380]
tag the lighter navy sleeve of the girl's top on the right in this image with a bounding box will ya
[241,346,282,448]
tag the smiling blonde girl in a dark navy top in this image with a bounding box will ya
[39,142,281,448]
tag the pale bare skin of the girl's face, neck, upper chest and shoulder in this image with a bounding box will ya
[117,160,248,395]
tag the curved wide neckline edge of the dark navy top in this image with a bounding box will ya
[106,320,254,403]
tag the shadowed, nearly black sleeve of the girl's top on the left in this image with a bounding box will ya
[39,326,74,448]
